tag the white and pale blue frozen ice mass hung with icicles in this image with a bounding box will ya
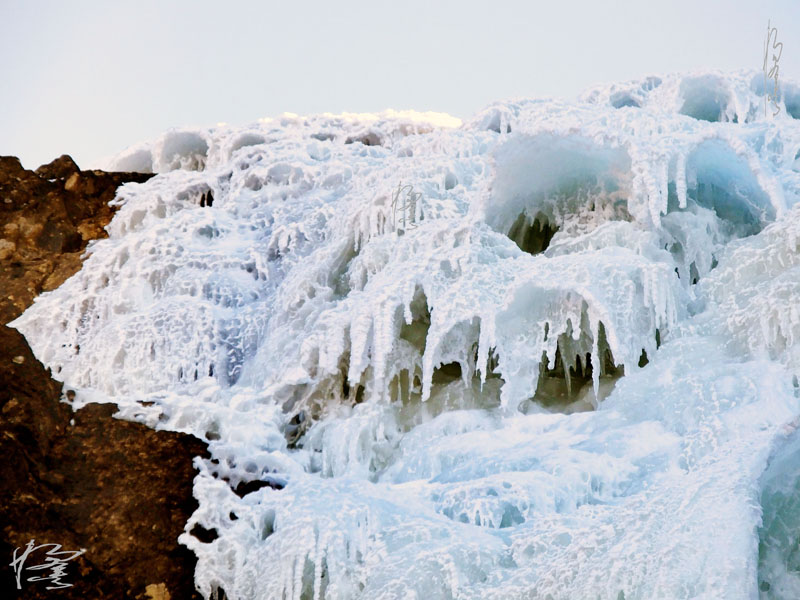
[14,73,800,600]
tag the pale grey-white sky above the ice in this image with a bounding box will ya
[0,0,800,168]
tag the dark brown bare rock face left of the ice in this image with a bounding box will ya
[0,156,207,600]
